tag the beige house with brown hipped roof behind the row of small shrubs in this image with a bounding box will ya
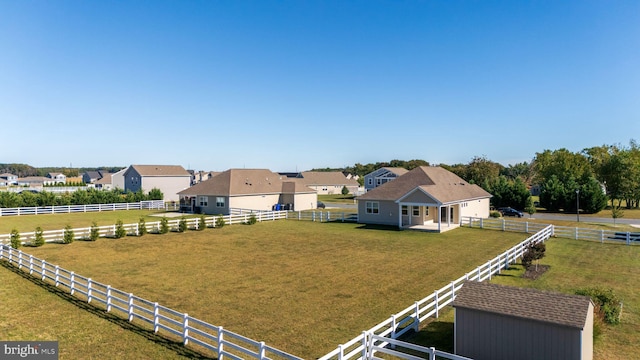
[178,169,318,215]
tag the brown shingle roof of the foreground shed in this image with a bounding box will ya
[453,281,591,329]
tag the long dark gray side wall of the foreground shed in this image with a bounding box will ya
[455,307,584,360]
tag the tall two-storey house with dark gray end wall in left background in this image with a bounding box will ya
[124,165,191,201]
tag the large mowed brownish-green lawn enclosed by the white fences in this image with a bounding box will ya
[4,220,526,359]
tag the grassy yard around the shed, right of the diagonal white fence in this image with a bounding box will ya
[404,238,640,360]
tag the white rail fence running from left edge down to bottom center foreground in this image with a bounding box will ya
[0,245,301,360]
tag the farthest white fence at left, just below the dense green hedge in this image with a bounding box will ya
[0,200,165,216]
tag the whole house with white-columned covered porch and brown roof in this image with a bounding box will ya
[357,166,491,232]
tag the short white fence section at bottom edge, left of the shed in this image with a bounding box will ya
[366,333,473,360]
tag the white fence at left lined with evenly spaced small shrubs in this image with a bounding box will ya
[0,211,287,244]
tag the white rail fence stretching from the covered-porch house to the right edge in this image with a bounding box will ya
[460,217,640,245]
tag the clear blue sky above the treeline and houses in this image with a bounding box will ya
[0,0,640,171]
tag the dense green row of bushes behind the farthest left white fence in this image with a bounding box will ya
[0,188,164,208]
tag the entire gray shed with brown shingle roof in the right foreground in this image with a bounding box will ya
[453,281,593,360]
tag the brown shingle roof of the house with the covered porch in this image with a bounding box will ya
[358,166,491,204]
